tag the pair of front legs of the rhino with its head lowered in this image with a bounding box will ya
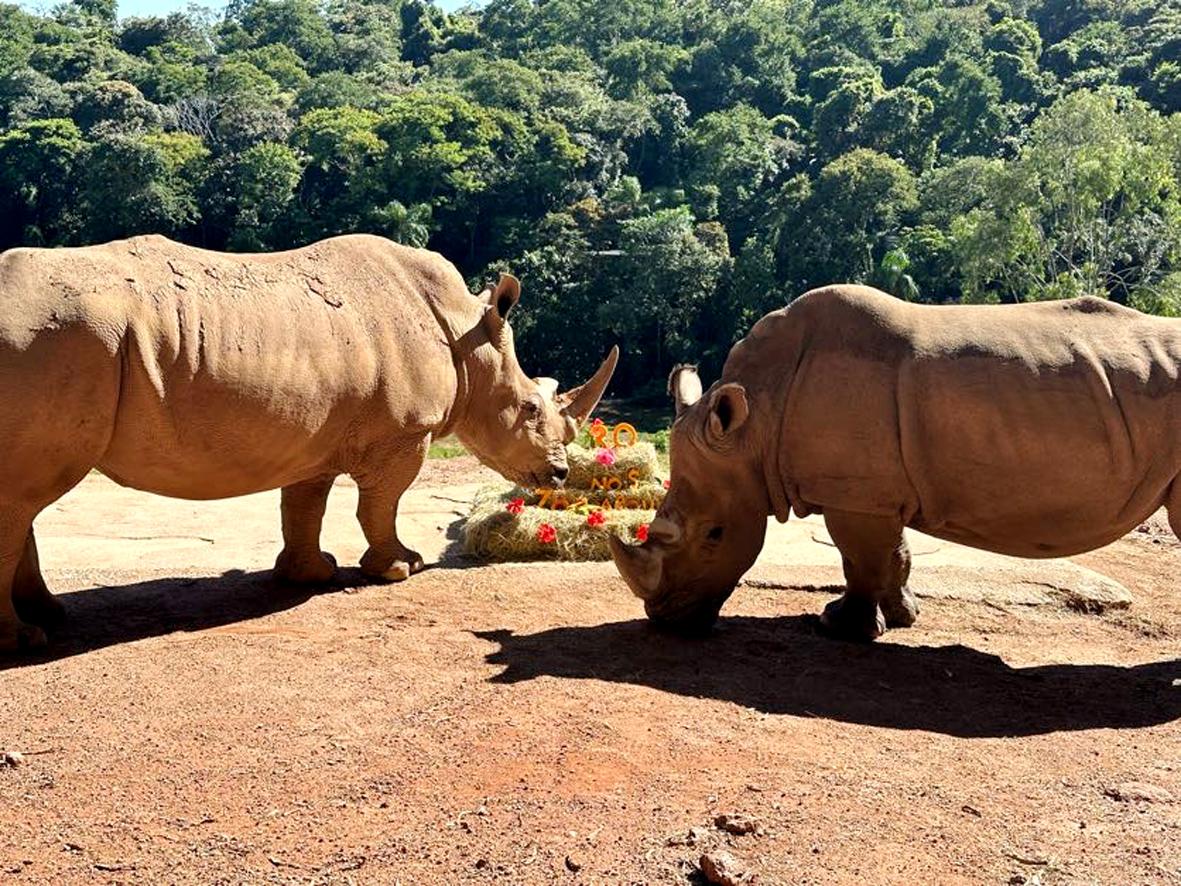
[821,509,919,640]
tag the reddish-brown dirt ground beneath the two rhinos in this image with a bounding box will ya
[0,458,1181,886]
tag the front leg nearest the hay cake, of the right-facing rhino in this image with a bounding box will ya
[357,437,430,581]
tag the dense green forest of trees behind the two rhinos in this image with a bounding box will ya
[0,0,1181,391]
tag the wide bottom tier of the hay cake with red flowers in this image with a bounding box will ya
[463,486,664,561]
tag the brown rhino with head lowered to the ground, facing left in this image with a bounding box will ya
[612,286,1181,639]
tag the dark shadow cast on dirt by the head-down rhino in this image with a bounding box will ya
[476,615,1181,738]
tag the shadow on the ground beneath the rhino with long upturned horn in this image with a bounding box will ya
[0,567,373,671]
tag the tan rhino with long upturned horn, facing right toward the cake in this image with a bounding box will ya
[0,235,619,650]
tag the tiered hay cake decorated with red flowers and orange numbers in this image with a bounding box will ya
[463,424,665,562]
